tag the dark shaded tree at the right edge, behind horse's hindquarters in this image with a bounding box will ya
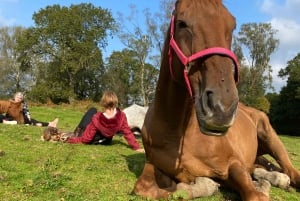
[270,53,300,135]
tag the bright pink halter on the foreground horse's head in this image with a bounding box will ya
[169,15,239,97]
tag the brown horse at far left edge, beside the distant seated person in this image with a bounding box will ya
[0,100,24,124]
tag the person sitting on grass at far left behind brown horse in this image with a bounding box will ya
[2,92,58,127]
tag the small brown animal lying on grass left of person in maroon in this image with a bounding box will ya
[41,126,74,142]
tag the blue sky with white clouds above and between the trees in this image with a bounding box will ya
[0,0,300,91]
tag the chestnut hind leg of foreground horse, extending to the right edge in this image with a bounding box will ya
[257,114,300,188]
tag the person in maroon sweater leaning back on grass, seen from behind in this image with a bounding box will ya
[67,91,144,152]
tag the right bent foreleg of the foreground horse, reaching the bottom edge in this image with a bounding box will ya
[225,162,269,201]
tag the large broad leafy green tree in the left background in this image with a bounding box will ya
[19,3,116,102]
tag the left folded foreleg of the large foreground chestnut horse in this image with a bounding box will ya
[133,162,176,200]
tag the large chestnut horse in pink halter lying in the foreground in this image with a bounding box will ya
[133,0,300,201]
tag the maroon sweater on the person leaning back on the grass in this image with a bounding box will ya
[68,109,139,150]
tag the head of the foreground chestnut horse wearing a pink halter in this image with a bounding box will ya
[169,0,239,135]
